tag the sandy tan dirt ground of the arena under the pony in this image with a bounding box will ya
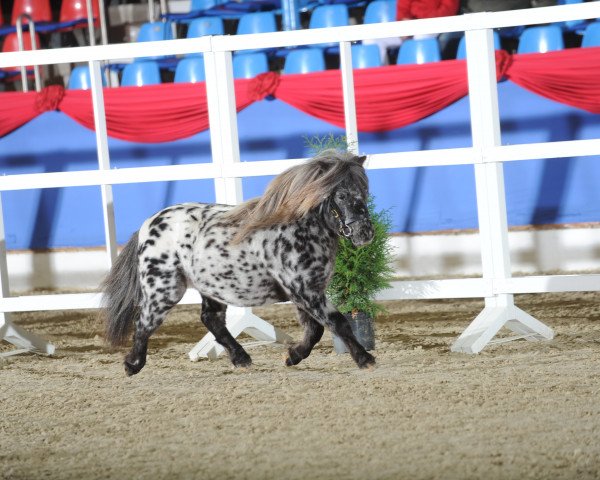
[0,293,600,480]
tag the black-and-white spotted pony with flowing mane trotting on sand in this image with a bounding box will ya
[101,150,375,375]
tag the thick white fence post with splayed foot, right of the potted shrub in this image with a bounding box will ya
[451,29,553,353]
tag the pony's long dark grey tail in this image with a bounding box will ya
[100,232,142,346]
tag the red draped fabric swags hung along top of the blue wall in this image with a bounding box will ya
[0,48,600,143]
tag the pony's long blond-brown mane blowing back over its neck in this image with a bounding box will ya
[225,149,368,242]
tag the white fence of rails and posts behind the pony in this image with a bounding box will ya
[0,2,600,353]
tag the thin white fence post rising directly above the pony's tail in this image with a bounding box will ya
[88,60,117,269]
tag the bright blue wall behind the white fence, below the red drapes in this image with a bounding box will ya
[0,82,600,248]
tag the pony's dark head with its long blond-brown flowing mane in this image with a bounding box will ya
[228,150,373,246]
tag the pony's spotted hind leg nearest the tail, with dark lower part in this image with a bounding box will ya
[124,271,186,376]
